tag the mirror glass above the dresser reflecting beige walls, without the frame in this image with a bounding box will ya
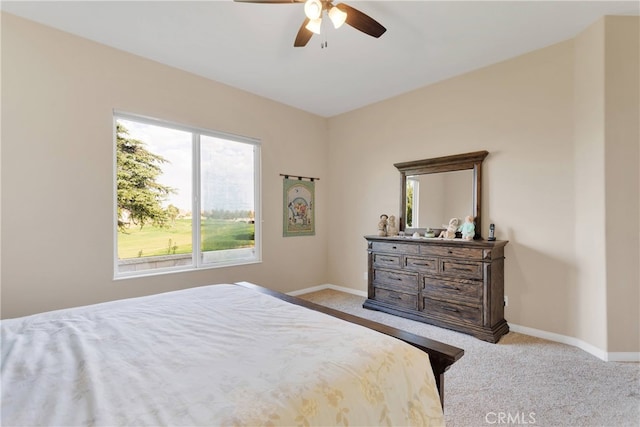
[404,170,474,229]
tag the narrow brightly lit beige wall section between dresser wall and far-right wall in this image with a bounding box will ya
[573,19,607,354]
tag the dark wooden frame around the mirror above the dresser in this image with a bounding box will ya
[393,151,489,239]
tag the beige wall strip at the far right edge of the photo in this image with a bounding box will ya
[604,17,640,352]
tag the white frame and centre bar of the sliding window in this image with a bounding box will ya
[113,110,262,280]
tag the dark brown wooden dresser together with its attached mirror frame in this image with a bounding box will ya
[363,151,509,343]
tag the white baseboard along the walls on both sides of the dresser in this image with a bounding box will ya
[288,283,640,362]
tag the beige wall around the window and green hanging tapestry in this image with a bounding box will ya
[2,14,329,317]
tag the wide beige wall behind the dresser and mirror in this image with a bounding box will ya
[329,37,576,333]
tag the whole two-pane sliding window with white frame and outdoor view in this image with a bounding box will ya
[114,113,261,277]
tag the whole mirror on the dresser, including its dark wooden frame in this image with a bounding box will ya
[394,151,489,239]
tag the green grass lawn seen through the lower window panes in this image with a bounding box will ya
[118,219,255,259]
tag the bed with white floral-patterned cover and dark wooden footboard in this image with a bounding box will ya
[1,282,463,426]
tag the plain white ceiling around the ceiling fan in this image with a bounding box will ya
[0,0,640,117]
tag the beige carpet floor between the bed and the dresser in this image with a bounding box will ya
[302,290,640,427]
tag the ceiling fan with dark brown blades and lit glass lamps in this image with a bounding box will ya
[234,0,387,47]
